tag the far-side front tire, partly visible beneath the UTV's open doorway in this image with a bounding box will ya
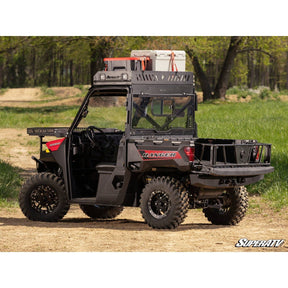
[79,204,123,219]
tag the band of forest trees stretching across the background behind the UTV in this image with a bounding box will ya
[0,36,288,101]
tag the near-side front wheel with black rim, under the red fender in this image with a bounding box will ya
[19,173,70,222]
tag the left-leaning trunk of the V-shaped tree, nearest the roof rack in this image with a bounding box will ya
[186,47,213,101]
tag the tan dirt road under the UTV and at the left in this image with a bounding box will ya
[0,90,288,252]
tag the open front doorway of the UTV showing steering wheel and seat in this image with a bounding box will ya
[67,87,130,206]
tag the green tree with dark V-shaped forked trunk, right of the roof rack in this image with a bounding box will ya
[185,36,288,100]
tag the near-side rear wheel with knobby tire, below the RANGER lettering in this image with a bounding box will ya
[140,177,189,229]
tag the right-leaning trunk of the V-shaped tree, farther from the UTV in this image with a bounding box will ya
[214,36,242,100]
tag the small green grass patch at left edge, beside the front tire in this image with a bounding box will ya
[0,160,22,207]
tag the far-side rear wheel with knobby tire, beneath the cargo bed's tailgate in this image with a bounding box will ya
[203,186,248,225]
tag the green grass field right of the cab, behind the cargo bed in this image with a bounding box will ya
[196,100,288,210]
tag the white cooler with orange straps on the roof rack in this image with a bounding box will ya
[131,50,186,71]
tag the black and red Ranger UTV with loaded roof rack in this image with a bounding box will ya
[19,50,274,229]
